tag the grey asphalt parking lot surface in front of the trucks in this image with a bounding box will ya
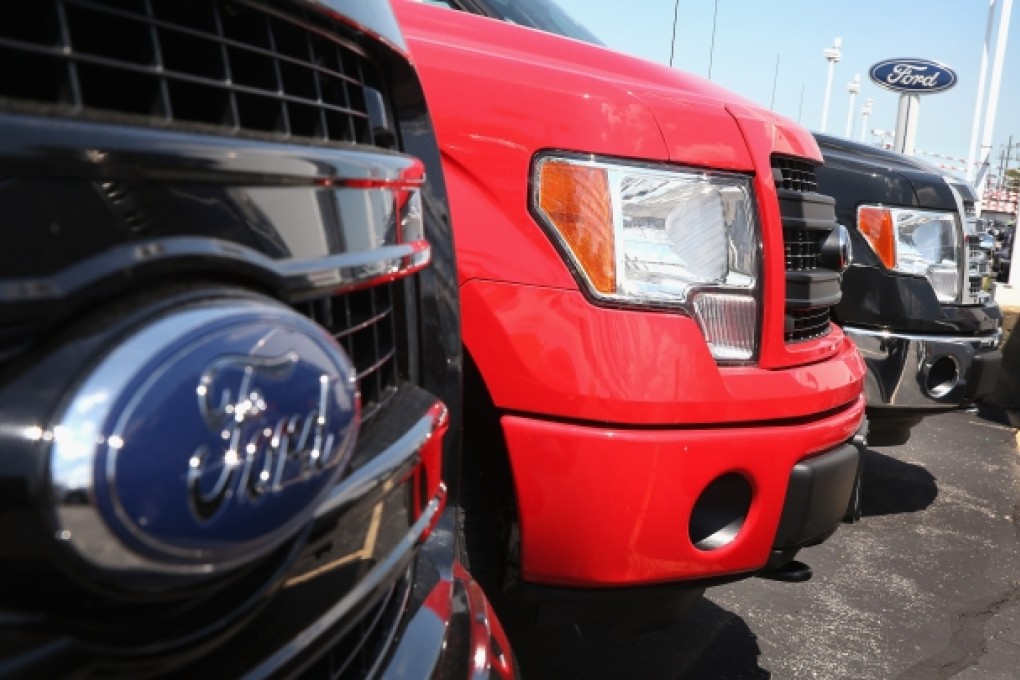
[517,412,1020,680]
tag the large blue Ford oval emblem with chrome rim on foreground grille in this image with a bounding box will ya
[50,300,359,573]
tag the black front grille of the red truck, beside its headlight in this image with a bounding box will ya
[772,156,834,343]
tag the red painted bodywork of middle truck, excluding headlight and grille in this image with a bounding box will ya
[394,0,864,585]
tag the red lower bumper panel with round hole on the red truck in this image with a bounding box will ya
[503,398,864,586]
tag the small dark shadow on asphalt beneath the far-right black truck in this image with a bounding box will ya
[861,449,938,517]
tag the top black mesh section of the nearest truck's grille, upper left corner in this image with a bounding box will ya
[0,0,381,144]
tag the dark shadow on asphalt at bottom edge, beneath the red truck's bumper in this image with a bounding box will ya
[511,597,771,680]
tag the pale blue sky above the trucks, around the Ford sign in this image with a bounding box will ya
[557,0,1020,180]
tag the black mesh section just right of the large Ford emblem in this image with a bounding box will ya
[298,281,400,434]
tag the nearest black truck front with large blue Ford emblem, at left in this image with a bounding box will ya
[0,0,514,678]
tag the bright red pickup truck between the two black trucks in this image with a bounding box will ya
[394,0,865,615]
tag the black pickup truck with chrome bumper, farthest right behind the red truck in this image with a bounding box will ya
[815,135,1003,446]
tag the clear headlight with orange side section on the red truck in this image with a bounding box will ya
[531,156,760,361]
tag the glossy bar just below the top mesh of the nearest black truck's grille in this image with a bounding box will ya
[0,111,420,190]
